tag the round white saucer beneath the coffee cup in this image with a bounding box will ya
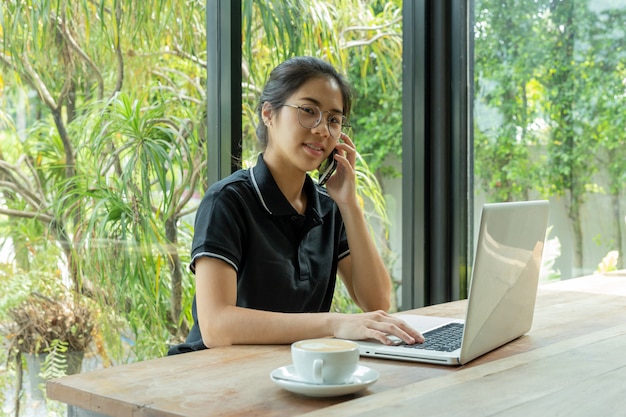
[270,365,379,397]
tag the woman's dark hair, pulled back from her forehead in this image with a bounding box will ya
[256,56,352,149]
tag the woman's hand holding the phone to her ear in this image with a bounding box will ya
[326,133,356,206]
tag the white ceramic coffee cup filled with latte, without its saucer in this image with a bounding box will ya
[291,339,359,385]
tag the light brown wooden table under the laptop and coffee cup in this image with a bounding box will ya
[47,276,626,417]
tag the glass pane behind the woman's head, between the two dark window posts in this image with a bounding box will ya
[242,0,402,310]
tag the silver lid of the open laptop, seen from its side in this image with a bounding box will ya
[460,200,548,363]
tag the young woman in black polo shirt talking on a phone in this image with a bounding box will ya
[170,57,423,354]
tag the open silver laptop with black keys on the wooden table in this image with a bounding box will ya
[356,200,548,365]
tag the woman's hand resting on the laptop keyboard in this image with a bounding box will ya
[326,310,424,345]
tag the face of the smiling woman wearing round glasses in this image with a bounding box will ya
[263,77,343,173]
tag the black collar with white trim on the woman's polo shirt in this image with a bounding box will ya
[250,153,330,219]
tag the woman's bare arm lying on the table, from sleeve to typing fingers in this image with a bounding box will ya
[195,257,421,347]
